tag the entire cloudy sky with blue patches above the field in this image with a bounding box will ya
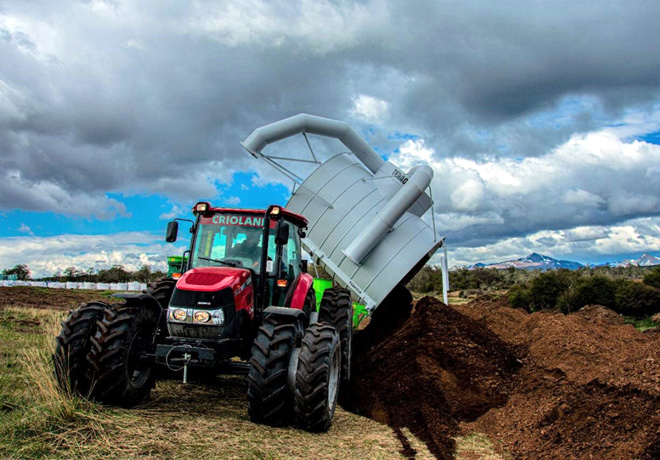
[0,0,660,276]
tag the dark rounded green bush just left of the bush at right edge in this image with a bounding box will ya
[557,276,619,313]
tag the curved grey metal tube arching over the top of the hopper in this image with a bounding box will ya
[241,113,385,174]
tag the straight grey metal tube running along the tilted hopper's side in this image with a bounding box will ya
[342,165,433,265]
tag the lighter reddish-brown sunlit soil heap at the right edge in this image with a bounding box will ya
[463,296,660,459]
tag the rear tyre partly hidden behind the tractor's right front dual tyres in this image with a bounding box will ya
[319,287,353,387]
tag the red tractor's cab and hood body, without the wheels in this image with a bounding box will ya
[158,202,315,364]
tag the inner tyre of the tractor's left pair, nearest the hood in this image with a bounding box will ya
[88,304,158,407]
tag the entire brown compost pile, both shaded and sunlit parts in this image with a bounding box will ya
[350,297,660,459]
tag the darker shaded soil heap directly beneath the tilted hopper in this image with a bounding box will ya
[351,297,520,458]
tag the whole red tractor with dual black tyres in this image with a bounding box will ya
[55,202,353,431]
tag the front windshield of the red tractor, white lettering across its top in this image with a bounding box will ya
[192,214,264,271]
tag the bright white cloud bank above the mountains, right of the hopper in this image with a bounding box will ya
[391,130,660,246]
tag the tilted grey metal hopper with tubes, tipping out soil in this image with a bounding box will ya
[241,114,447,310]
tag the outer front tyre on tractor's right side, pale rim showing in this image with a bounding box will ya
[294,323,341,432]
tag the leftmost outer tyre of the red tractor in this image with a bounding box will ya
[53,302,109,396]
